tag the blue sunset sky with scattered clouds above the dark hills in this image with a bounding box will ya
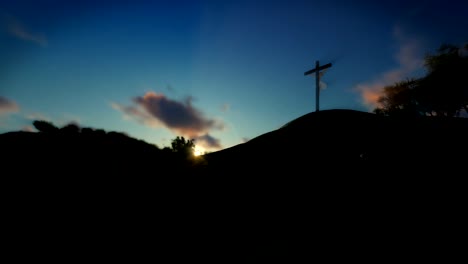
[0,0,468,152]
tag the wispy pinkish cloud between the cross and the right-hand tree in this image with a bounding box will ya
[355,27,424,109]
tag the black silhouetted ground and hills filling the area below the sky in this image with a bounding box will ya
[0,110,468,263]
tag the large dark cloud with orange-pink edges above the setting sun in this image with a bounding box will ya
[111,92,224,138]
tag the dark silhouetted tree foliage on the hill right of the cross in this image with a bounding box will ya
[374,45,468,117]
